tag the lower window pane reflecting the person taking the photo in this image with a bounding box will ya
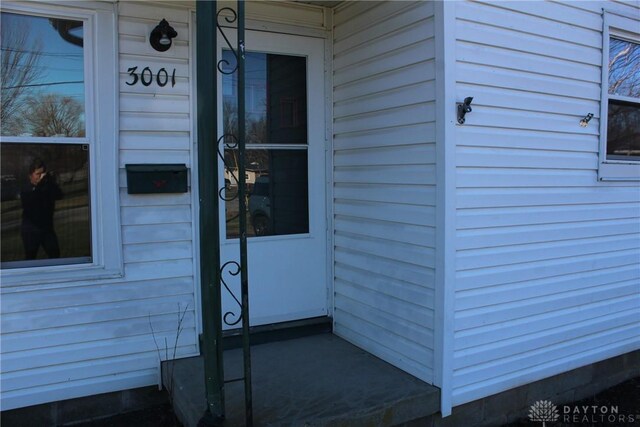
[0,143,91,268]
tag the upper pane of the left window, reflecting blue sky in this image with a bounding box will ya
[0,13,85,137]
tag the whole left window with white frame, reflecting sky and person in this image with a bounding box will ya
[0,2,121,285]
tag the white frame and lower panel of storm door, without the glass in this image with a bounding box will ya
[217,31,330,328]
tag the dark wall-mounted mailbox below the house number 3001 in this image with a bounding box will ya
[125,164,187,194]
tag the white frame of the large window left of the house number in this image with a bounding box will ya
[0,1,124,287]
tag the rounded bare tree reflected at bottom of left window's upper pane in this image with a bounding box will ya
[25,94,84,136]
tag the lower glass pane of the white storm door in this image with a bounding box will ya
[225,150,309,239]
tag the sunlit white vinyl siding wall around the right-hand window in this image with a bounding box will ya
[453,1,640,405]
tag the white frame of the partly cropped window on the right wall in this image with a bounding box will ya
[598,10,640,181]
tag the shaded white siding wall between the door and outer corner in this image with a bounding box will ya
[333,2,435,382]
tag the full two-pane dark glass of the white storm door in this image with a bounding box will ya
[222,50,309,239]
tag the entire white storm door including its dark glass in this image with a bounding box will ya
[218,32,328,328]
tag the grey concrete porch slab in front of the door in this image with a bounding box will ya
[164,334,440,427]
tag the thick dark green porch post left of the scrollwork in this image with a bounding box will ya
[196,1,225,426]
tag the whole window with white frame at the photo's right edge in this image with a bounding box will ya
[599,13,640,180]
